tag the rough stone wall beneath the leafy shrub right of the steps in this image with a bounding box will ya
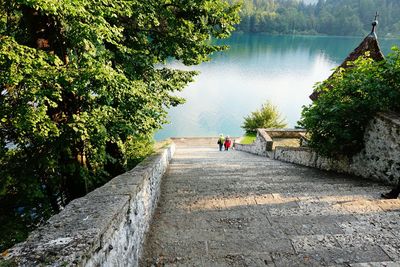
[274,113,400,184]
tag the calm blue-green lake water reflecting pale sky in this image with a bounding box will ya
[155,33,400,140]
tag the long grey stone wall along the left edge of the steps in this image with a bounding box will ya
[0,144,175,266]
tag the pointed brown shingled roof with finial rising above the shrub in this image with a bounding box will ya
[310,17,385,101]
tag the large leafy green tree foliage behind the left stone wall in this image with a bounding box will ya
[0,0,239,250]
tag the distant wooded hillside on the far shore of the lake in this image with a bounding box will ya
[230,0,400,36]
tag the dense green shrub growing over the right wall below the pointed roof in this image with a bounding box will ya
[299,48,400,156]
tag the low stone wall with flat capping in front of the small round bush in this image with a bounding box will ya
[235,129,305,157]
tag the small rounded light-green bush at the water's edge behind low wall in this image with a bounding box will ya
[241,101,287,133]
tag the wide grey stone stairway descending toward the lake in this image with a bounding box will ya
[141,142,400,266]
